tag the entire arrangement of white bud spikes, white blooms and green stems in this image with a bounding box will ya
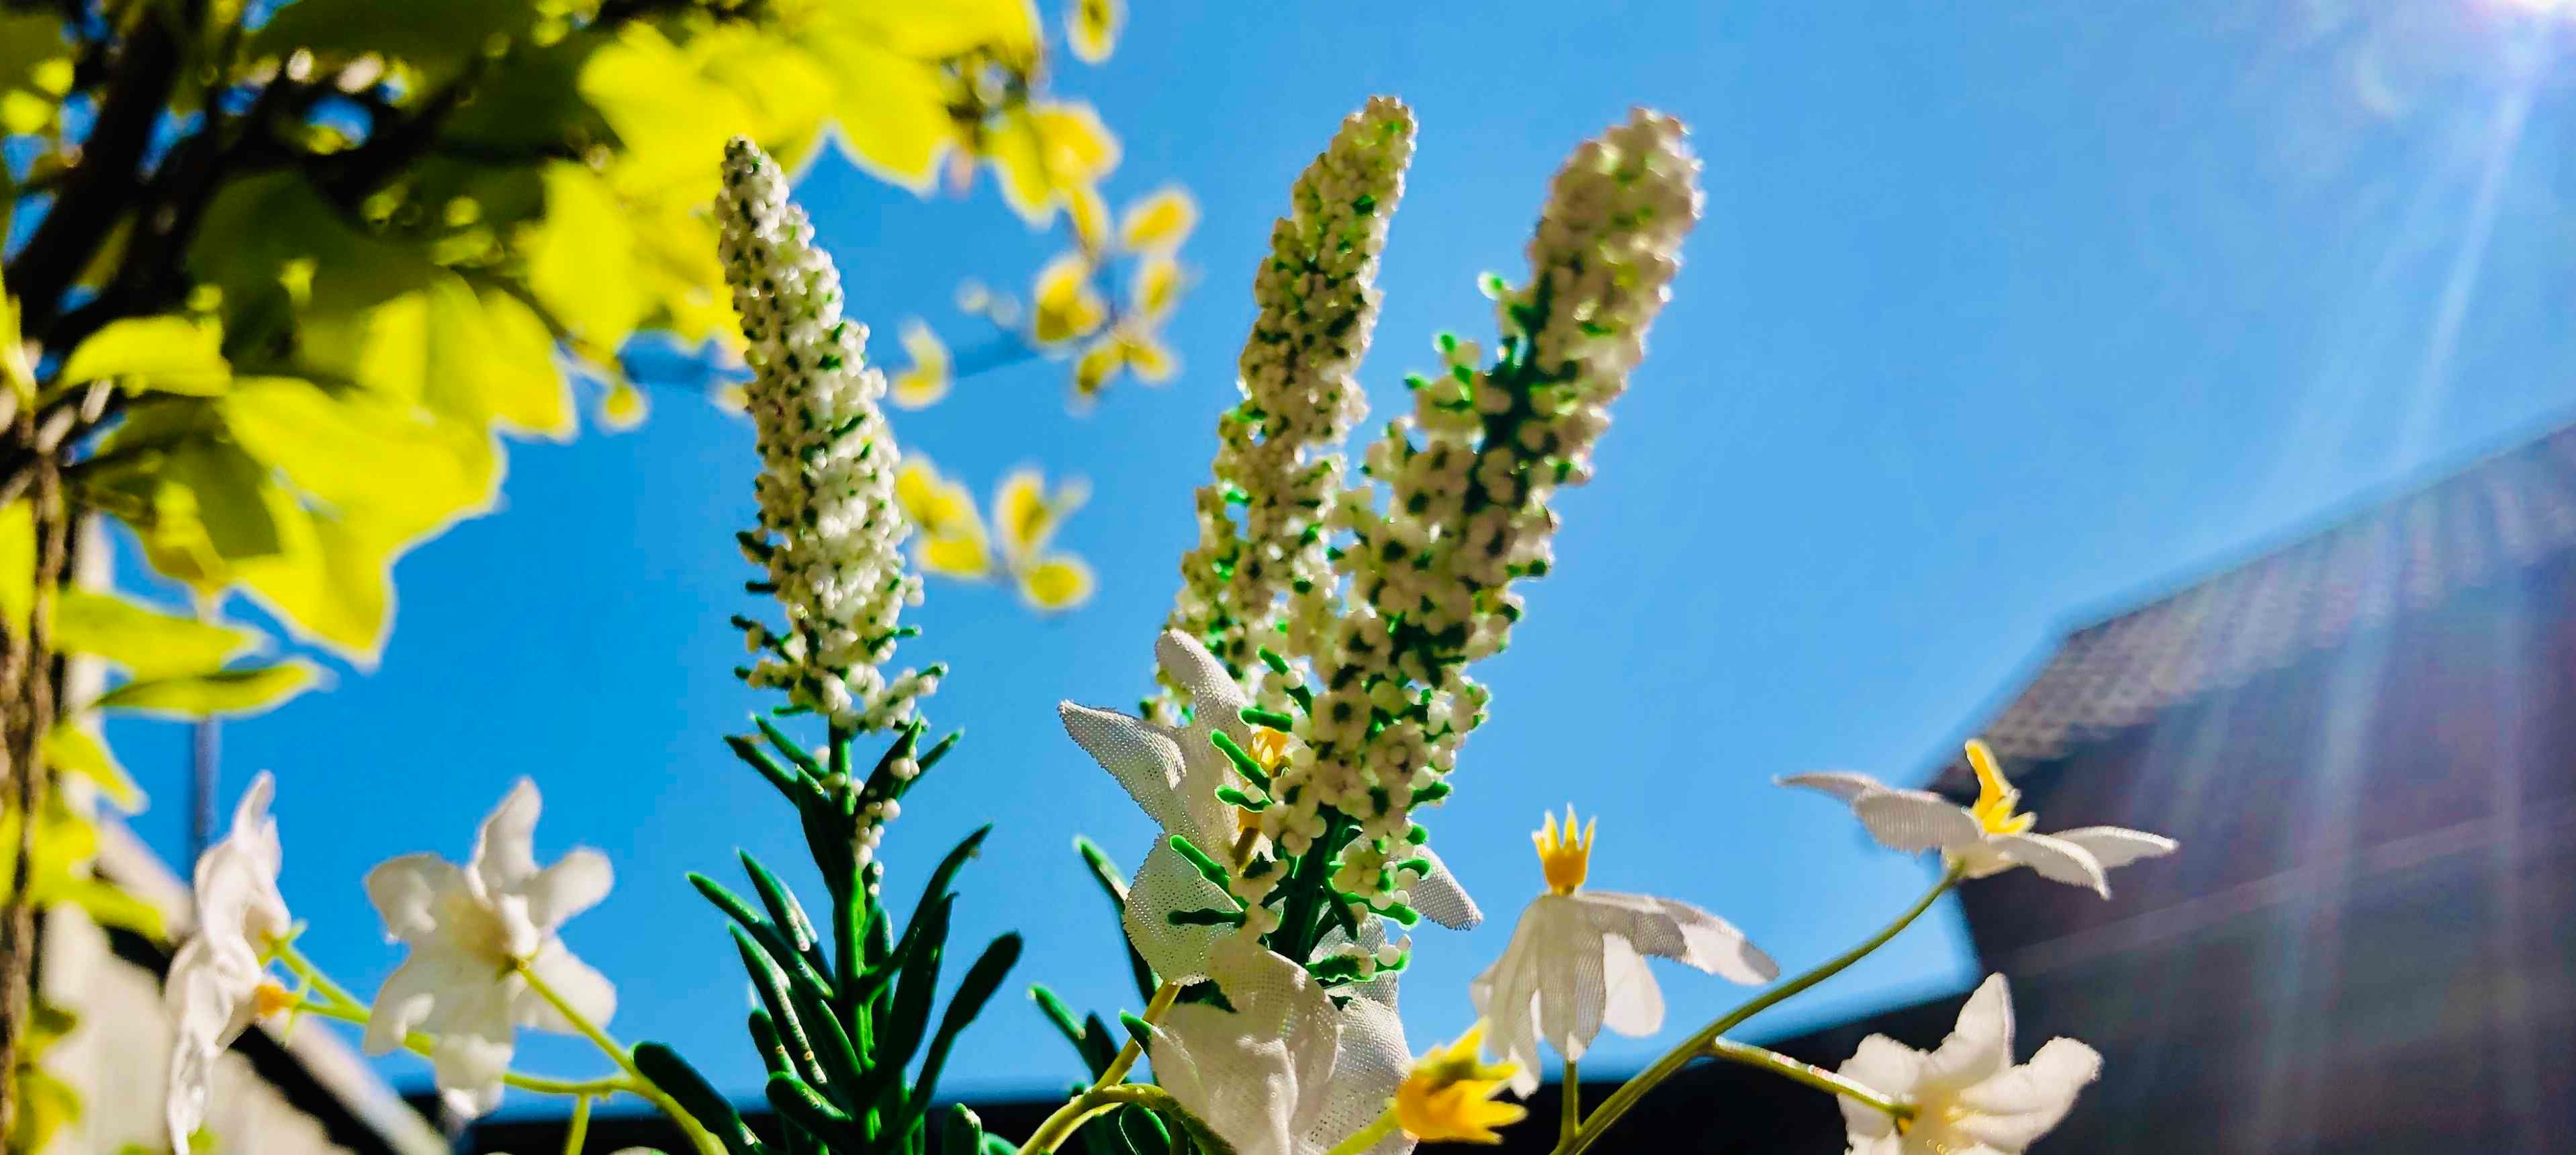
[167,98,2174,1155]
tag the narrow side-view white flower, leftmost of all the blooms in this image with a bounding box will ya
[163,771,293,1155]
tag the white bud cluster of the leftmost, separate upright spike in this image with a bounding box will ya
[716,136,943,732]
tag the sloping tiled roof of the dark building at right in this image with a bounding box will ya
[1981,425,2576,766]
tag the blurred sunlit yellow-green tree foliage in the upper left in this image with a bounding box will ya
[0,0,1190,1127]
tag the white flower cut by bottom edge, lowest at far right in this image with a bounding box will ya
[1839,974,2102,1155]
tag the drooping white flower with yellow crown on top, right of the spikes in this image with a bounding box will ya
[1469,807,1780,1096]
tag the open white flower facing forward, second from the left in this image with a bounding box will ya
[366,778,618,1116]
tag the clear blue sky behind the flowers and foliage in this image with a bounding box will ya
[100,0,2576,1109]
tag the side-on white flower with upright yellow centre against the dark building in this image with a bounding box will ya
[1780,740,2176,897]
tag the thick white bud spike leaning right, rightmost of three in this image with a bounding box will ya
[1262,111,1700,910]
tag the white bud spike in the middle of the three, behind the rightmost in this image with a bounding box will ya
[1154,95,1414,722]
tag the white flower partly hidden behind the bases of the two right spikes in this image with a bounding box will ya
[1056,632,1484,982]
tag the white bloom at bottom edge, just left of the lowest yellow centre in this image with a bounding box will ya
[1146,936,1412,1155]
